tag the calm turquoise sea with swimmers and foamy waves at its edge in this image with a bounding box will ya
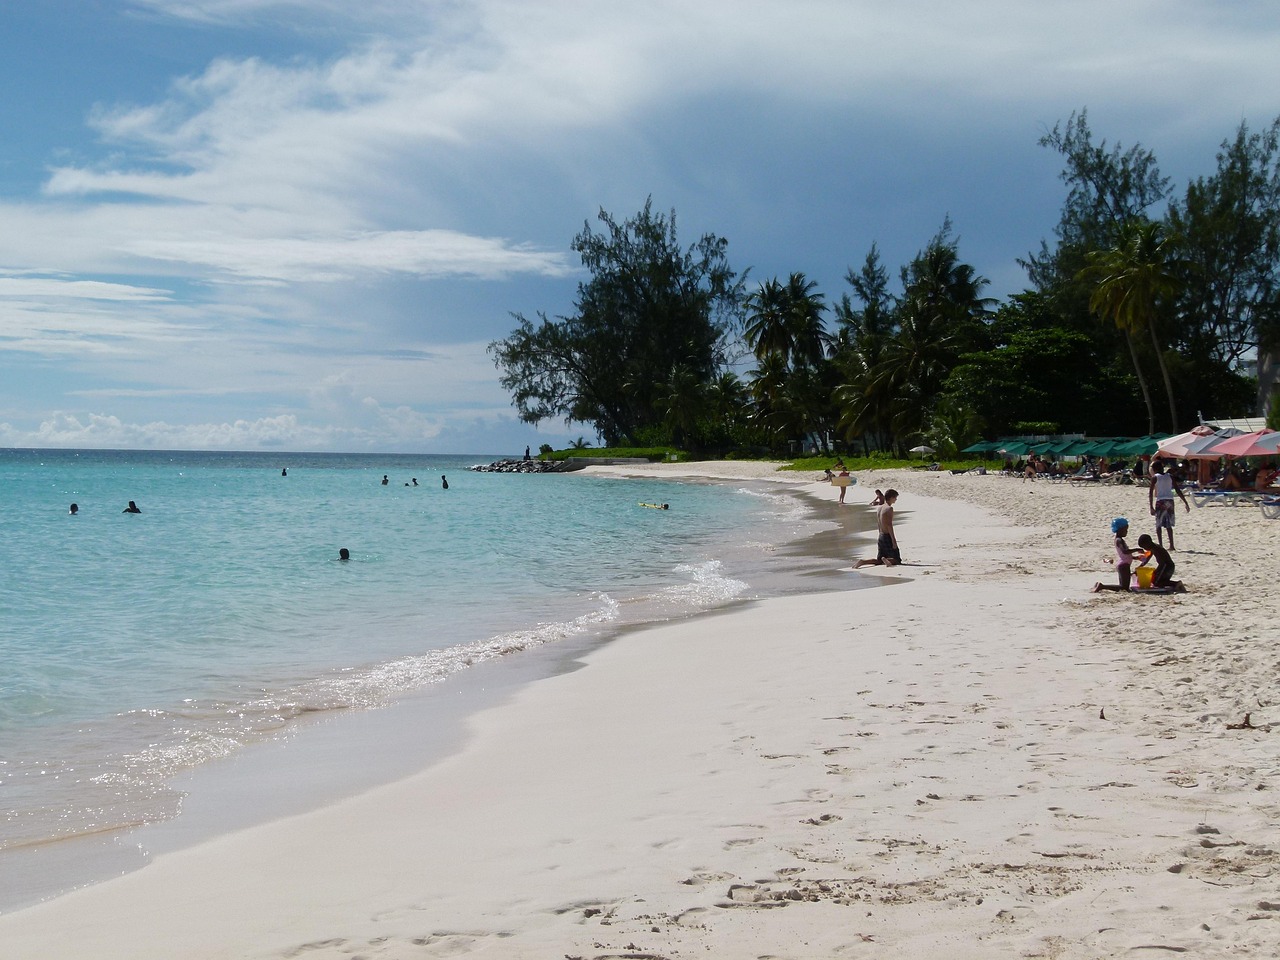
[0,451,803,850]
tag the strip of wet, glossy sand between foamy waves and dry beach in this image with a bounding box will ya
[0,477,865,915]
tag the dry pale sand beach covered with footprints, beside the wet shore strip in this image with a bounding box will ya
[0,463,1280,960]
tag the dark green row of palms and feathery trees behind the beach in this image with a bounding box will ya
[489,110,1280,454]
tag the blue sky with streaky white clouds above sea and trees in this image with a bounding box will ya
[0,0,1280,454]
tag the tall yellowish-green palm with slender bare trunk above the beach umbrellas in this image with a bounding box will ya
[1076,220,1179,433]
